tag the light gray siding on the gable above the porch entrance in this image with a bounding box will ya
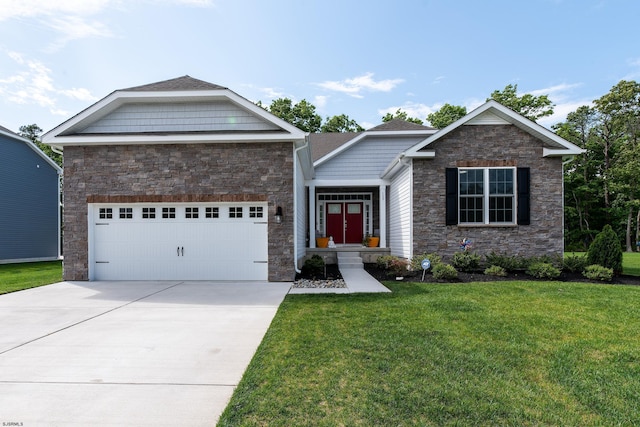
[316,137,424,179]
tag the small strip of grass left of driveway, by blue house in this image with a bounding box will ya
[0,261,62,294]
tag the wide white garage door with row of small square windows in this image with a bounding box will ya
[89,203,268,280]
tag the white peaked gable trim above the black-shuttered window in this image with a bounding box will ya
[405,100,584,157]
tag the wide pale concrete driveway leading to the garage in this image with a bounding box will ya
[0,282,291,427]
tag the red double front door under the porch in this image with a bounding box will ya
[326,202,363,243]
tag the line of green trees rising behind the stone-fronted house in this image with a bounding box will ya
[19,80,640,251]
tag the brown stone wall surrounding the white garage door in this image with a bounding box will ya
[63,142,295,281]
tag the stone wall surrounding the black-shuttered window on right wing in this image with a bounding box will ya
[413,125,564,258]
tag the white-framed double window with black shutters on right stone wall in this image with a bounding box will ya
[447,167,529,225]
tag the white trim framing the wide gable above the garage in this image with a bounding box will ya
[42,89,306,148]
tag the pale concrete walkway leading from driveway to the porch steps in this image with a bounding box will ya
[289,252,391,294]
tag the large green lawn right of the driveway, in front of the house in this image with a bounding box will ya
[219,282,640,426]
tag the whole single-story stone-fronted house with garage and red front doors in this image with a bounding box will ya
[43,76,581,281]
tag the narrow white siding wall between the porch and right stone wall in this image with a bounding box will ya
[389,167,413,259]
